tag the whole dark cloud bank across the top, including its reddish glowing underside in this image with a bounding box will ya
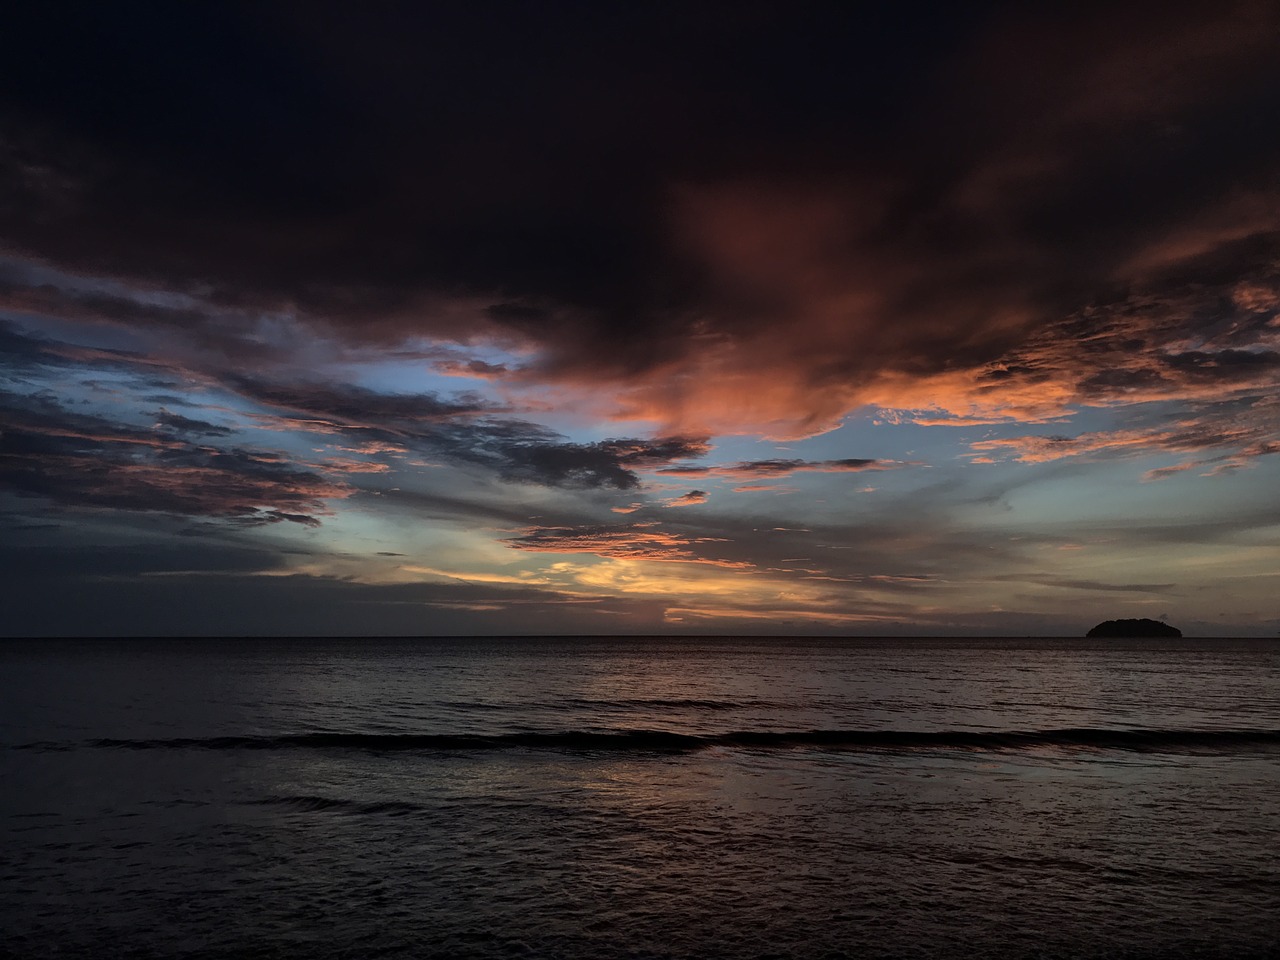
[0,3,1280,435]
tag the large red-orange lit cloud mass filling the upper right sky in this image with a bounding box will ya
[486,3,1280,439]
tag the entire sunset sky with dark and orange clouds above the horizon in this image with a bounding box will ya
[0,0,1280,636]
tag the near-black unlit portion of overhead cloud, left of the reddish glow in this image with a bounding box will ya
[0,4,968,317]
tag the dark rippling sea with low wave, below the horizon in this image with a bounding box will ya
[0,639,1280,959]
